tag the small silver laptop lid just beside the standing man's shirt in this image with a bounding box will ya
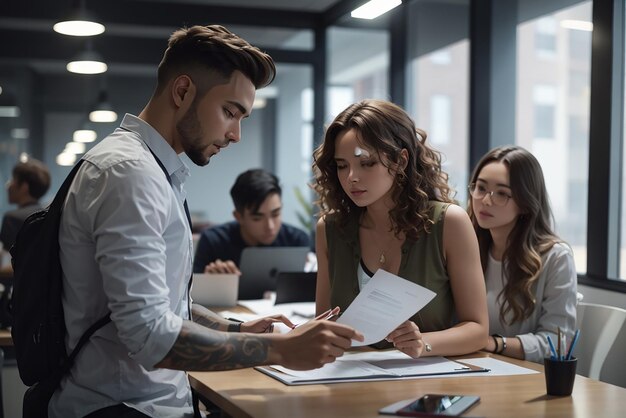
[191,273,239,307]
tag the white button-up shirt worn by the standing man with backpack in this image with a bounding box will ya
[49,115,193,418]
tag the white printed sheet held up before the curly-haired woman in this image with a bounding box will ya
[337,269,436,347]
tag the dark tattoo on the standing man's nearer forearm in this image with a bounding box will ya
[157,321,269,371]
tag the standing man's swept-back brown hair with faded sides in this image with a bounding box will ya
[157,25,276,94]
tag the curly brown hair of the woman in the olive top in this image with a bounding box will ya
[313,99,453,239]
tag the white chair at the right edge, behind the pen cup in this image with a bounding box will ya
[573,302,626,387]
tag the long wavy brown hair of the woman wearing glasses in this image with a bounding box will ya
[468,146,562,324]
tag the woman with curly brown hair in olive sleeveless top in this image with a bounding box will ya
[313,100,488,358]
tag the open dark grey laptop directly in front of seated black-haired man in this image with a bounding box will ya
[239,247,310,300]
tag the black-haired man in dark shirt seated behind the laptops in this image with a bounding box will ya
[193,169,310,274]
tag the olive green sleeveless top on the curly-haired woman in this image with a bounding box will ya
[325,201,456,332]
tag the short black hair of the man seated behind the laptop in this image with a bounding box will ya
[230,168,282,214]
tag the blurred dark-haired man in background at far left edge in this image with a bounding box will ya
[0,158,50,251]
